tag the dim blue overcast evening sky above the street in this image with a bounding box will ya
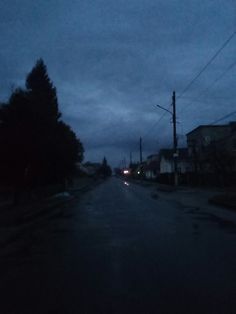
[0,0,236,166]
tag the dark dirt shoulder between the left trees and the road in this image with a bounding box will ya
[0,178,103,260]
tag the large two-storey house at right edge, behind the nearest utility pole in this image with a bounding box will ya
[186,122,236,184]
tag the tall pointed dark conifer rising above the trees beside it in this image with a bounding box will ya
[26,59,83,182]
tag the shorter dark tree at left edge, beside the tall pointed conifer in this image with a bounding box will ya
[0,89,32,185]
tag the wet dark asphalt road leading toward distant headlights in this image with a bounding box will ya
[0,178,236,314]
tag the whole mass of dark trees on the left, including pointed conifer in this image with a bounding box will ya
[0,60,84,194]
